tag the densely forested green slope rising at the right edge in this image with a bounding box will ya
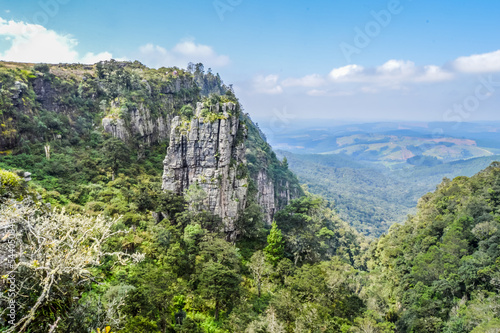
[369,163,500,332]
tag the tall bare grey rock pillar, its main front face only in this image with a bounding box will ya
[163,103,248,233]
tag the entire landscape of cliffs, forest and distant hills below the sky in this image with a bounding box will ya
[0,61,500,333]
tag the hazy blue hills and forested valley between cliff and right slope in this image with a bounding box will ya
[270,123,500,236]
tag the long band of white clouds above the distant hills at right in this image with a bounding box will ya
[254,50,500,96]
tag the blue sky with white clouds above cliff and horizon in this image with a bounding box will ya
[0,0,500,128]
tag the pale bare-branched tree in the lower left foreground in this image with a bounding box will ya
[0,198,144,332]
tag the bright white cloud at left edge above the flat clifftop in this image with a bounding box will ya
[0,17,112,63]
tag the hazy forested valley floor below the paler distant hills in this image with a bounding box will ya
[277,150,500,237]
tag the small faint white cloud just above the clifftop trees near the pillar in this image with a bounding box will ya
[139,41,230,67]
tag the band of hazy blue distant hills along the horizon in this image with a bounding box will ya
[269,122,500,162]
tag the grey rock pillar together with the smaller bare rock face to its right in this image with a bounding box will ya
[163,103,300,239]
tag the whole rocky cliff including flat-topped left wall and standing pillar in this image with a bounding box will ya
[0,61,302,237]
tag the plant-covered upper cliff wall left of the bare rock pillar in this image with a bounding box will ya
[0,60,221,155]
